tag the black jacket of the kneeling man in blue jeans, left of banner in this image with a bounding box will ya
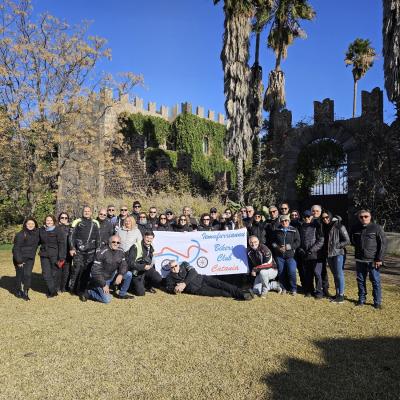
[90,247,128,287]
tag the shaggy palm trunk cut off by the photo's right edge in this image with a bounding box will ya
[383,0,400,120]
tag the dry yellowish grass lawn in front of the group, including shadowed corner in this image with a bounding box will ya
[0,249,400,400]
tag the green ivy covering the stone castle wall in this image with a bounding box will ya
[120,113,235,190]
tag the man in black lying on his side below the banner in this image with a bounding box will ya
[166,261,254,300]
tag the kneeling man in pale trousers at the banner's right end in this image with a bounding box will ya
[247,235,282,297]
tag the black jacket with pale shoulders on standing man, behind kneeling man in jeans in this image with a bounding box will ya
[69,217,100,253]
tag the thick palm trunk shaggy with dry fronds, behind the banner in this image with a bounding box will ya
[214,0,254,202]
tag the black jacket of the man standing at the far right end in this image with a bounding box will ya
[351,223,387,261]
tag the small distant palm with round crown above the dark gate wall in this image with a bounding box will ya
[344,38,376,118]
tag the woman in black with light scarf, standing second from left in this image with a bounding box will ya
[39,215,66,298]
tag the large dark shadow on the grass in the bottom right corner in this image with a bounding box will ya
[264,337,400,400]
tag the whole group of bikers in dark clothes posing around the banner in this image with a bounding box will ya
[13,201,386,309]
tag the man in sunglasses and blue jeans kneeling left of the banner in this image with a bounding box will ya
[80,235,133,304]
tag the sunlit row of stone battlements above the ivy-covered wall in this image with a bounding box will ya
[99,89,225,125]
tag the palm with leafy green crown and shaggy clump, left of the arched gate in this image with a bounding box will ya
[264,0,315,133]
